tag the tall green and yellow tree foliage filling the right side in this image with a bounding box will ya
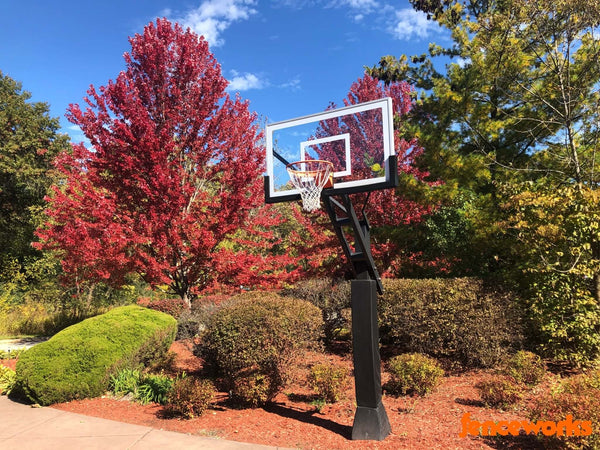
[370,0,600,364]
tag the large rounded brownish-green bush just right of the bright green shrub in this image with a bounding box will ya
[194,292,322,405]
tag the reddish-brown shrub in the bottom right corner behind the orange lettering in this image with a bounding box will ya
[529,370,600,450]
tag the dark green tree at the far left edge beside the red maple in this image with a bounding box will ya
[0,72,68,281]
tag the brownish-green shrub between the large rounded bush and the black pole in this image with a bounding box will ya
[283,278,351,342]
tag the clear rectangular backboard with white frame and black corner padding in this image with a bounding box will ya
[265,98,397,203]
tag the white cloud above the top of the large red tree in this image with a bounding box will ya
[174,0,257,47]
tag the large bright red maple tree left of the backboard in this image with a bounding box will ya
[38,19,263,304]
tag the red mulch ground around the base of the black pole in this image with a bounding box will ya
[2,341,543,450]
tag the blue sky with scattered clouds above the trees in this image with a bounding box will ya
[0,0,448,142]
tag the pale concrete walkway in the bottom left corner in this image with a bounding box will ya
[0,395,286,450]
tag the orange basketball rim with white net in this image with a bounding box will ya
[286,159,333,212]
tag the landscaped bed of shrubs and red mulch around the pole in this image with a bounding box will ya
[0,279,600,449]
